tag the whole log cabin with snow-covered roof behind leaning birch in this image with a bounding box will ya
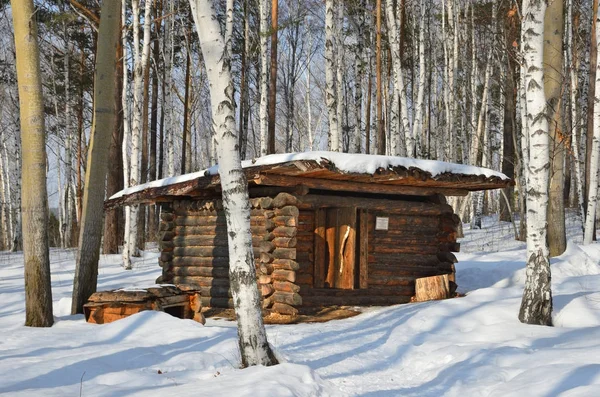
[105,152,512,315]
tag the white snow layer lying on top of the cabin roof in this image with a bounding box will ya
[109,151,510,200]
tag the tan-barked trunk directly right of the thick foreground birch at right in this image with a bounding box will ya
[544,0,567,256]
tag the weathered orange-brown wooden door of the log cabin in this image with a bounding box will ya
[315,208,357,289]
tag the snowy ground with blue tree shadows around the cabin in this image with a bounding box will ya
[0,213,600,397]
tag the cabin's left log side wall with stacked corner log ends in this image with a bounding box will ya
[157,193,302,315]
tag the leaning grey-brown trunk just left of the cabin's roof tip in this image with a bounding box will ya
[71,0,121,314]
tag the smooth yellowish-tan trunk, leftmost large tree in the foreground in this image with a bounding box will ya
[11,0,54,327]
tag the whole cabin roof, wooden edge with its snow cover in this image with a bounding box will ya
[107,151,511,206]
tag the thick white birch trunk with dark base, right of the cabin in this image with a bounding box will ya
[519,0,552,325]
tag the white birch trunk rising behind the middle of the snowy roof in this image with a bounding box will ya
[325,0,340,152]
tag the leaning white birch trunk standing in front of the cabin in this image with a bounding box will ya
[190,0,277,366]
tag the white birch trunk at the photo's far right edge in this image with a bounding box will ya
[583,4,600,244]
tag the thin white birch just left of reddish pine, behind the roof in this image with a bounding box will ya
[259,0,271,156]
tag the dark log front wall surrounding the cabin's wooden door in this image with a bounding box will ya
[298,193,460,306]
